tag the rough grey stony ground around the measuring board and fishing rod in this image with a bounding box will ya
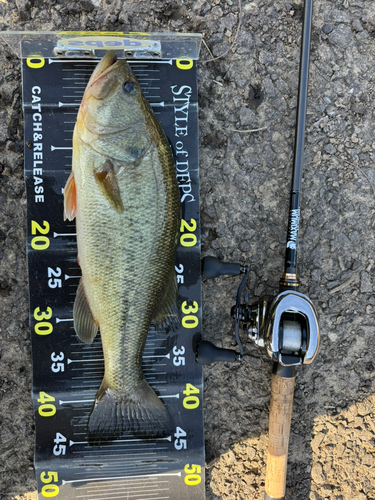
[0,0,375,500]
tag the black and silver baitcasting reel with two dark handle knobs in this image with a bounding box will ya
[196,257,319,366]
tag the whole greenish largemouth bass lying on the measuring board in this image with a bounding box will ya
[64,52,180,442]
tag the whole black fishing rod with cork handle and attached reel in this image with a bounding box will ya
[196,0,320,500]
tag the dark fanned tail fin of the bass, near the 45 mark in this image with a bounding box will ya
[88,379,172,445]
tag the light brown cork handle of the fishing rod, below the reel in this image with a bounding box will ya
[265,374,295,500]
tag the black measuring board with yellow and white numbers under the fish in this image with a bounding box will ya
[22,44,205,500]
